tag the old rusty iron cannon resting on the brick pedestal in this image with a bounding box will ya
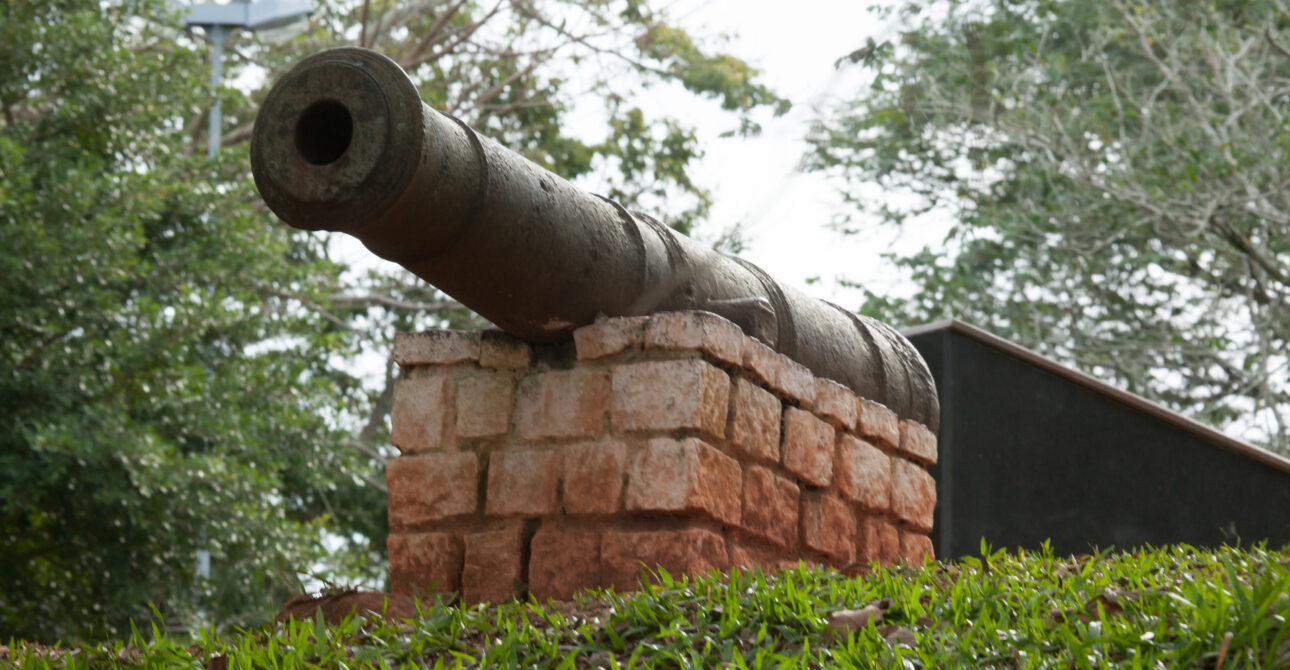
[250,48,939,430]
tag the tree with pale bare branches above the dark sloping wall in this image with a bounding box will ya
[809,0,1290,452]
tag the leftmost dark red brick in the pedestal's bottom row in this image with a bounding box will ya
[386,533,462,596]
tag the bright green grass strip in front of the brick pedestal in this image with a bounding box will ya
[0,546,1290,669]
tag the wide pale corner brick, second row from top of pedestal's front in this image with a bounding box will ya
[609,359,730,439]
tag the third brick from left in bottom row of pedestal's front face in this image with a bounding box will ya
[529,525,601,602]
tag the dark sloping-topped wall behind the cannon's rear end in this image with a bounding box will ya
[909,327,1290,558]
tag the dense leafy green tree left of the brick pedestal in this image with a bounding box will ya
[0,0,376,639]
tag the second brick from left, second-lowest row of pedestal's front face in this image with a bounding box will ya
[484,449,560,518]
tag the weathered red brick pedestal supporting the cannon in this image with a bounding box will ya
[386,312,937,603]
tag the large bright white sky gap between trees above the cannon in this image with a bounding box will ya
[671,0,934,307]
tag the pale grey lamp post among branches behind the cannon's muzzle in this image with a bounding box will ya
[183,0,313,157]
